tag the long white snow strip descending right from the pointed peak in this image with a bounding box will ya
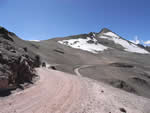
[100,32,149,54]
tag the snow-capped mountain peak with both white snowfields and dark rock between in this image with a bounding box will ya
[58,28,149,54]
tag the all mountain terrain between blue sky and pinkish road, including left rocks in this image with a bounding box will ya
[0,27,150,113]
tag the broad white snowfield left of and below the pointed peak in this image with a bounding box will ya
[58,37,108,54]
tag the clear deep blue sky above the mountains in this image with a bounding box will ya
[0,0,150,44]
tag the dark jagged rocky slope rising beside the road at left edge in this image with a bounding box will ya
[0,27,39,91]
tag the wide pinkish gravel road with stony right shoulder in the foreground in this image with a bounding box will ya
[0,68,150,113]
